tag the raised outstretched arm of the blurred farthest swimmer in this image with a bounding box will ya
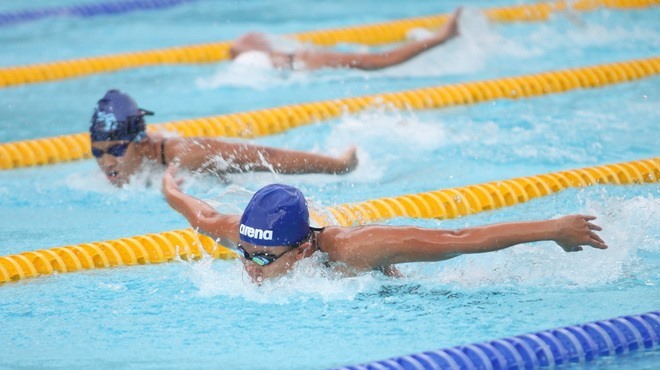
[299,8,461,70]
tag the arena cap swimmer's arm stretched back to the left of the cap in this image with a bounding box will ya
[162,165,240,246]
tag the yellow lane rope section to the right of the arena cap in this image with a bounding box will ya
[313,157,660,226]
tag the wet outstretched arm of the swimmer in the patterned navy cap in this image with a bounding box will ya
[168,138,358,174]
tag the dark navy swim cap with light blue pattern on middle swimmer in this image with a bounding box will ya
[89,90,154,142]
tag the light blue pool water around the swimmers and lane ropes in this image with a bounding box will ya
[0,0,660,369]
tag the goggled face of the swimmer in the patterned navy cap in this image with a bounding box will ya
[92,140,142,186]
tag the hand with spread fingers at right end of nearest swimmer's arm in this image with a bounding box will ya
[554,215,607,252]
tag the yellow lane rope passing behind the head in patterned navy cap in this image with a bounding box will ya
[0,57,660,170]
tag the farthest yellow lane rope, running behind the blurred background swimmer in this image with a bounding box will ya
[0,0,660,88]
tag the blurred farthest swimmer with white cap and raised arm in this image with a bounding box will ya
[229,7,461,70]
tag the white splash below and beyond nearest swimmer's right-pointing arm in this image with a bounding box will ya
[408,189,660,289]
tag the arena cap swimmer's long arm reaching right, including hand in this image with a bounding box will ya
[336,215,607,268]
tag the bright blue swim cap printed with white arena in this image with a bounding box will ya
[238,184,310,247]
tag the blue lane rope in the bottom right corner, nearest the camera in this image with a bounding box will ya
[340,311,660,370]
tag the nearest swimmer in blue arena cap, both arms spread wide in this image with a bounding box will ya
[162,166,607,282]
